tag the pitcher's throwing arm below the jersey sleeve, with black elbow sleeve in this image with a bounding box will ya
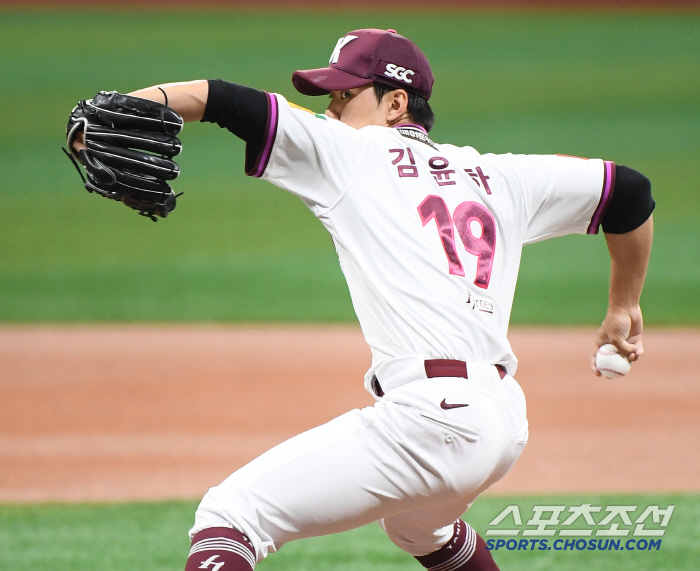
[591,166,655,376]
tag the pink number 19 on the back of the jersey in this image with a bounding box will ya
[418,194,496,289]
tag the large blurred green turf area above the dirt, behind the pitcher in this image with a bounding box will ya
[0,10,700,325]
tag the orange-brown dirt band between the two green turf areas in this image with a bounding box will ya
[0,326,700,502]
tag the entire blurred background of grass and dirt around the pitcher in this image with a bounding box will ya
[0,0,700,571]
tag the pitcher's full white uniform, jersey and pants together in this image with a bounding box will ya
[190,94,614,560]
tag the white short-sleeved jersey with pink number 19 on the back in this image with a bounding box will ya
[248,94,614,398]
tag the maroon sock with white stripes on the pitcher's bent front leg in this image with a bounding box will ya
[185,527,255,571]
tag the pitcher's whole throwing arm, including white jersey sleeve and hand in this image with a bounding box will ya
[508,155,655,374]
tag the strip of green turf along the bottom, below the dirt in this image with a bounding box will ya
[0,494,700,571]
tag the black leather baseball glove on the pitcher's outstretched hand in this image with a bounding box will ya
[64,91,183,222]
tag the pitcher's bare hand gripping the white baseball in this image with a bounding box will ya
[590,305,644,377]
